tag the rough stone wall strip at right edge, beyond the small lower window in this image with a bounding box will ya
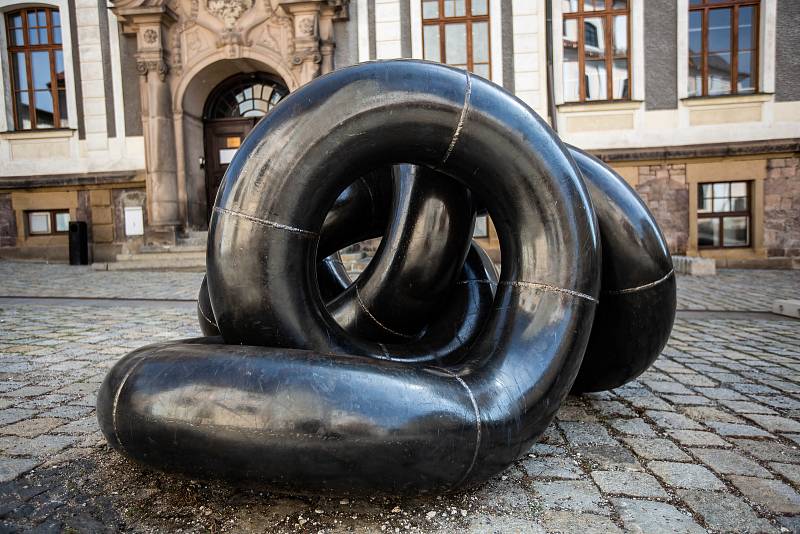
[764,157,800,258]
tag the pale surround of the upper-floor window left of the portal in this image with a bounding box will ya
[0,0,78,137]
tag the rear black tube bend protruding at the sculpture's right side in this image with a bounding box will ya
[569,147,676,392]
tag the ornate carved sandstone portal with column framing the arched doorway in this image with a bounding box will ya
[112,0,349,243]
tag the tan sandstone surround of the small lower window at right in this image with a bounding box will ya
[686,158,767,259]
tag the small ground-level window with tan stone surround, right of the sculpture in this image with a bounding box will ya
[697,182,751,248]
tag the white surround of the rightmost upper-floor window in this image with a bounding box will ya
[677,0,778,100]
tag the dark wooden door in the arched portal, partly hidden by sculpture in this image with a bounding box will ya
[205,117,260,220]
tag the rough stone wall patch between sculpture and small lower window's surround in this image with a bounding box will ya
[635,163,689,254]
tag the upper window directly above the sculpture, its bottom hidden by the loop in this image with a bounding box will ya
[422,0,491,79]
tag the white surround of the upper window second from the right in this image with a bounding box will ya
[553,0,644,106]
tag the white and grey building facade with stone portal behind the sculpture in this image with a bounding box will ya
[0,0,800,267]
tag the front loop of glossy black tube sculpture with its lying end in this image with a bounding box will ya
[98,61,600,493]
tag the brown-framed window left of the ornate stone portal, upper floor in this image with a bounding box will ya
[6,7,67,130]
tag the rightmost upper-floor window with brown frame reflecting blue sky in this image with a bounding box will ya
[689,0,759,96]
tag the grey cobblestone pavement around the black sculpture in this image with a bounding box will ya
[0,263,800,534]
